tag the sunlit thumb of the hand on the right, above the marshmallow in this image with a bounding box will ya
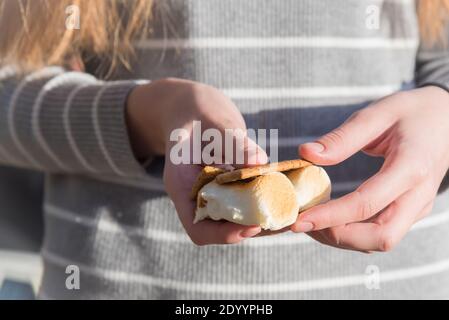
[299,105,392,165]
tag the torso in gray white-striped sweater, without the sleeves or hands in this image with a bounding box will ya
[42,0,449,299]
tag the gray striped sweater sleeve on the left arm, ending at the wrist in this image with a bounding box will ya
[0,67,150,177]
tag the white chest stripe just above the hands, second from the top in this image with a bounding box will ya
[222,84,401,100]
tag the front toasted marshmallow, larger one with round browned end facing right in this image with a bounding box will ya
[195,172,299,230]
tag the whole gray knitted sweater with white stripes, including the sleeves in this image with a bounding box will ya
[0,0,449,299]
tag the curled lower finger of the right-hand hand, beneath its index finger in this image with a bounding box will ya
[312,189,431,252]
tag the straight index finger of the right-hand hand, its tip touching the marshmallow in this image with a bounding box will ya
[292,153,427,232]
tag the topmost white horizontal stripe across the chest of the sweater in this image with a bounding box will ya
[135,37,418,50]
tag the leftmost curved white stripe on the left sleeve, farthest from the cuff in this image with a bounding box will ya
[7,67,63,168]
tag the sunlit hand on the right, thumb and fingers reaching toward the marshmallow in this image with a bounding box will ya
[292,86,449,252]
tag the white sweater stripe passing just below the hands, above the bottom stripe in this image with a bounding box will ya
[45,204,449,247]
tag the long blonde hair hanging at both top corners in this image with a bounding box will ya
[0,0,449,73]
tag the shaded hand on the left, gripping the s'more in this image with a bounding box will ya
[127,79,267,245]
